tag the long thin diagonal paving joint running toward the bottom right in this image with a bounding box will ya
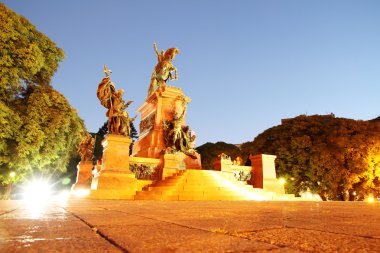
[101,207,296,252]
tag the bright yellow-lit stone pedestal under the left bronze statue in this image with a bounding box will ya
[90,134,138,199]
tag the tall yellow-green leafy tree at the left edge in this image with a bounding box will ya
[0,4,85,197]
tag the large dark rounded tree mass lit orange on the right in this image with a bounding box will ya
[241,115,380,200]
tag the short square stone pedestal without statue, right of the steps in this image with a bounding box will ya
[250,154,285,194]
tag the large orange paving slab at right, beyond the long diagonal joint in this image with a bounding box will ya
[69,201,380,252]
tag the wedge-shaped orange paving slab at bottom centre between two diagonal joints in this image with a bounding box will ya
[98,223,279,253]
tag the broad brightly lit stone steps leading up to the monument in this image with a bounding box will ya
[135,170,294,200]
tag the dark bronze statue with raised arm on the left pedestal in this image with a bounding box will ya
[96,65,136,136]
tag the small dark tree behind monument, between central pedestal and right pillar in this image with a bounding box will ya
[197,142,241,170]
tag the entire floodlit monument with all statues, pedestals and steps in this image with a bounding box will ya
[77,43,288,200]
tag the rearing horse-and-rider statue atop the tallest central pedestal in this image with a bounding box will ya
[148,42,179,96]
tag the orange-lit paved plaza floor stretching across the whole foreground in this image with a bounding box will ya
[0,199,380,253]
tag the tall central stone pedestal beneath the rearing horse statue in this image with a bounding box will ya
[132,85,201,169]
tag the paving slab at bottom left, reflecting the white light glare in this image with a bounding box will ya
[0,206,121,253]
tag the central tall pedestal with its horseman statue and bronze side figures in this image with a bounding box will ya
[132,43,201,175]
